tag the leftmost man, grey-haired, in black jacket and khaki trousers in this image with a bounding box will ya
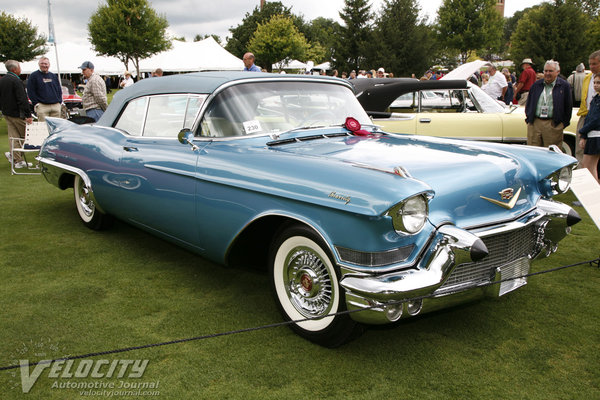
[0,60,33,168]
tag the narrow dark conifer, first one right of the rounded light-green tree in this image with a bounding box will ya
[332,0,374,71]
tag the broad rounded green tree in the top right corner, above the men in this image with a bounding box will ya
[511,0,590,76]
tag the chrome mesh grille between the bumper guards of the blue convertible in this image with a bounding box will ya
[435,224,538,295]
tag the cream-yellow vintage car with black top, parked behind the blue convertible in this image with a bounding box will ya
[354,78,578,155]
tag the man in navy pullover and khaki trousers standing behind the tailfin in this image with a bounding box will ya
[27,57,62,121]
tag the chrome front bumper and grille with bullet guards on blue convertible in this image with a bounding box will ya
[340,200,580,324]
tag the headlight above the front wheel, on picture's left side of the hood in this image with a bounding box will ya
[386,193,430,235]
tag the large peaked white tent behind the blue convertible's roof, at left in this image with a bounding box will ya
[0,37,244,75]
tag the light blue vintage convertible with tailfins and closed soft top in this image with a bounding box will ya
[39,72,579,347]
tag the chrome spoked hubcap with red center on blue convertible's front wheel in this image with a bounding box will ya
[284,248,333,317]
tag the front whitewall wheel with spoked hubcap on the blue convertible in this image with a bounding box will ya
[269,225,362,347]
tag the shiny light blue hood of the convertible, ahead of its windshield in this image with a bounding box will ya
[274,135,571,227]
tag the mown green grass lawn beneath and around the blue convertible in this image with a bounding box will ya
[0,113,600,400]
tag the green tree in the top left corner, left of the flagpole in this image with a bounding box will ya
[0,11,46,62]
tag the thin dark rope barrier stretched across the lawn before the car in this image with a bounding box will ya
[0,257,600,371]
